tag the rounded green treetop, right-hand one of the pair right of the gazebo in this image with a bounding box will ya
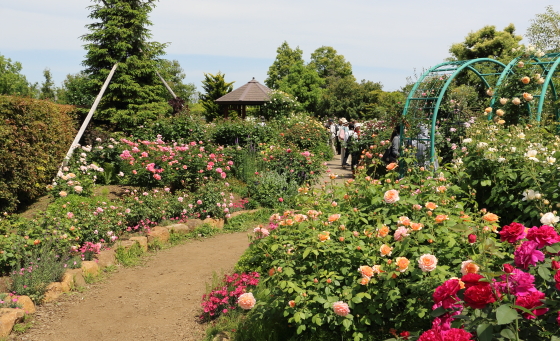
[309,46,355,81]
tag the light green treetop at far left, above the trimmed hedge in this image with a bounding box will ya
[0,55,36,96]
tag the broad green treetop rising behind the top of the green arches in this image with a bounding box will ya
[449,24,522,64]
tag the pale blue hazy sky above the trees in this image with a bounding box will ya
[0,0,560,91]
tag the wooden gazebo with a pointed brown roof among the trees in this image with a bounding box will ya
[216,77,272,118]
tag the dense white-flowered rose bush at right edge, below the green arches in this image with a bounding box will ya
[453,120,560,226]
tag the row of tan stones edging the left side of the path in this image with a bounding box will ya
[4,209,257,337]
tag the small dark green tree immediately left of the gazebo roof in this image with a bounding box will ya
[200,72,235,121]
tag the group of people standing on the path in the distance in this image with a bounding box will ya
[327,117,360,171]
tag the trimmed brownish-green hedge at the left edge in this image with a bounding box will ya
[0,96,76,212]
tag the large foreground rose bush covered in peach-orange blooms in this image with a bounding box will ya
[237,155,500,340]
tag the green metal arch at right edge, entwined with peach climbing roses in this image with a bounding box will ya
[488,53,560,122]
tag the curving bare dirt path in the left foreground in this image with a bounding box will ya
[10,232,248,341]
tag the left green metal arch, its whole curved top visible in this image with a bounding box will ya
[401,58,507,163]
